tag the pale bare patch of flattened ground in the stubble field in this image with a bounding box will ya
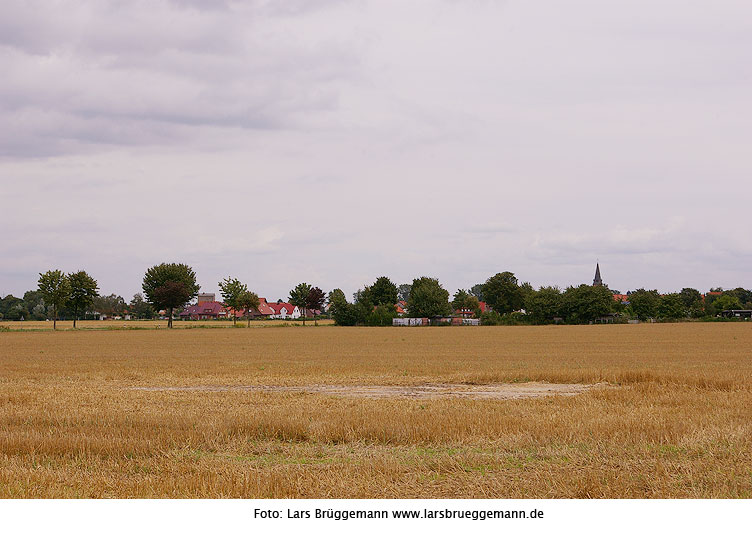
[133,382,606,399]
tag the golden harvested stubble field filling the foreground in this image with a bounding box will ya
[0,323,752,498]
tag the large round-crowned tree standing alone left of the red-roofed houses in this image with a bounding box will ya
[141,264,199,329]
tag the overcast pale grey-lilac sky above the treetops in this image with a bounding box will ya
[0,0,752,300]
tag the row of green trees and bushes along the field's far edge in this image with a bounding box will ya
[0,263,752,328]
